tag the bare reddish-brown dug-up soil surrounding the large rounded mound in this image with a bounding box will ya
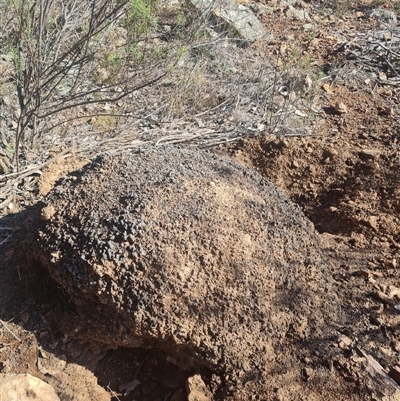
[0,2,400,401]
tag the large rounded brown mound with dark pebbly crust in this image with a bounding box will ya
[27,146,334,379]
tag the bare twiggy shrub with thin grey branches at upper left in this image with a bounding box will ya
[0,0,197,169]
